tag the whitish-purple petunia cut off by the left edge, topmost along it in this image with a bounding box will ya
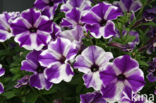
[0,12,20,42]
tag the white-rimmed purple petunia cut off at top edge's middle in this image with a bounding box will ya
[61,0,91,12]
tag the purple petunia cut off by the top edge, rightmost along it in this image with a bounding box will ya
[114,0,142,12]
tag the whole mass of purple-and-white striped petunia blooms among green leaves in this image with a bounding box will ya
[0,0,156,103]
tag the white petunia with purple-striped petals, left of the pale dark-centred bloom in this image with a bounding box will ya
[39,38,77,83]
